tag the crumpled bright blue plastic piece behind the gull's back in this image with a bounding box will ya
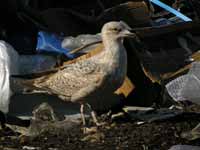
[36,31,74,58]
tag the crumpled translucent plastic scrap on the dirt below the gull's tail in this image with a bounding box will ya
[23,103,80,137]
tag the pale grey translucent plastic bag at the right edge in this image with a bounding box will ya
[166,62,200,104]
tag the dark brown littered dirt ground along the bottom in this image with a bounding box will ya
[0,110,200,150]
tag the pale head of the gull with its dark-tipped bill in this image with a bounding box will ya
[101,21,136,40]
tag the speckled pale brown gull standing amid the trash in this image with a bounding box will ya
[13,21,135,130]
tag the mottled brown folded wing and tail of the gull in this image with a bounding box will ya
[11,60,105,100]
